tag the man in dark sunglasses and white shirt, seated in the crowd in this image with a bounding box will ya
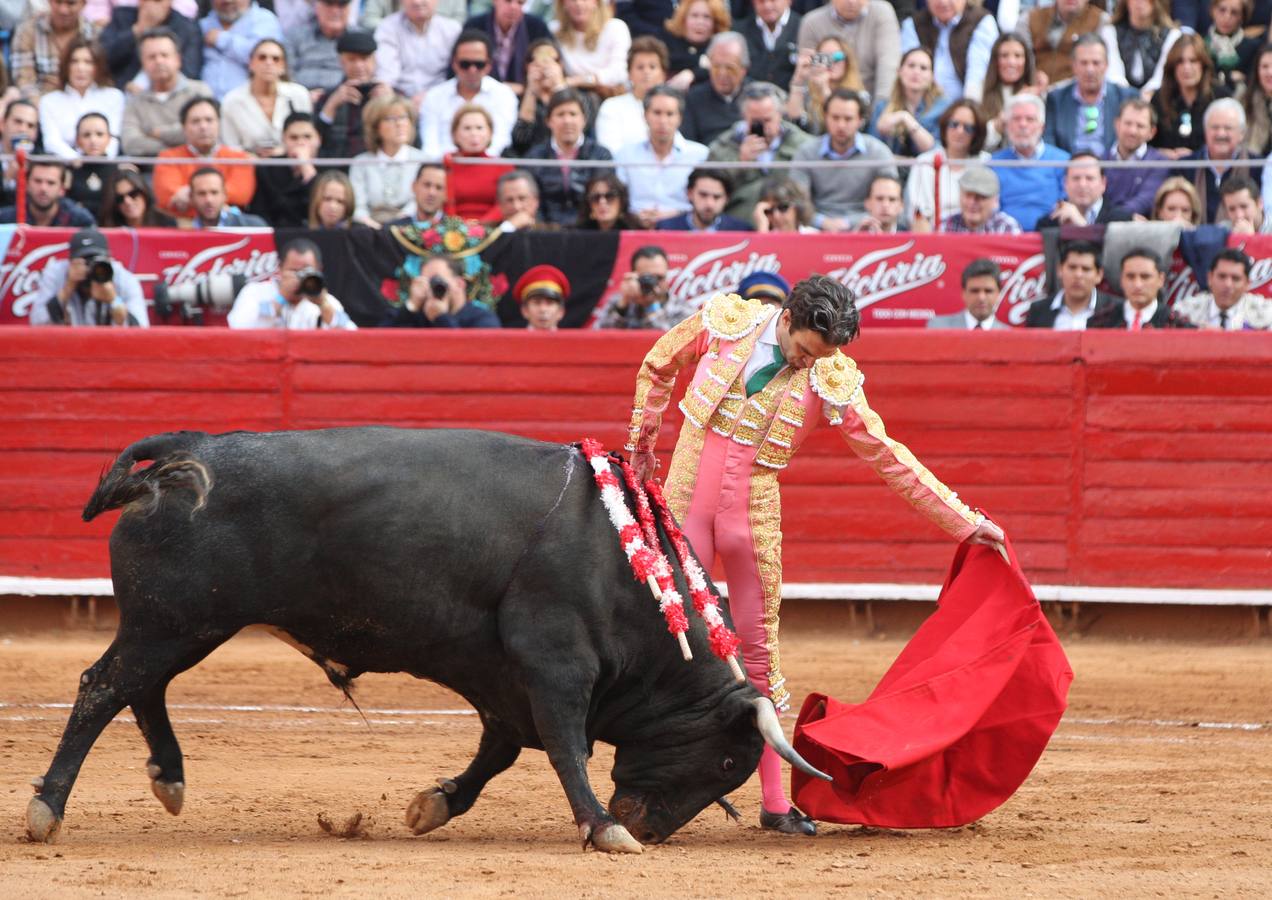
[420,29,518,159]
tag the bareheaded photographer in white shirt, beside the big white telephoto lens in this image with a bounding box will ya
[226,238,357,331]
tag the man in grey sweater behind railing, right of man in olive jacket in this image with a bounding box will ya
[791,88,897,231]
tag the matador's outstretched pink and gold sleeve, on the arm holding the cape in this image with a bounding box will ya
[838,388,985,542]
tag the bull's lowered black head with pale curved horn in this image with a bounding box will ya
[609,692,831,844]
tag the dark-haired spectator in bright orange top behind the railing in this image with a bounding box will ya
[154,97,256,219]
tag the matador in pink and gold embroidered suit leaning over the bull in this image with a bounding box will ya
[627,276,1004,834]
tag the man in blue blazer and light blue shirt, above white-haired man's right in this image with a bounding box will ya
[1043,34,1138,156]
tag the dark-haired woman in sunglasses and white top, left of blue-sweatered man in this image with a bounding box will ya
[906,99,990,231]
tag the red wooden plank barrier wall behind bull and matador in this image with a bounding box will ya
[0,328,1272,587]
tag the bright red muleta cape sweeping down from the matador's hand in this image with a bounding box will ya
[791,543,1074,828]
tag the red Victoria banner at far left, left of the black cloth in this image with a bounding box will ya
[0,226,279,325]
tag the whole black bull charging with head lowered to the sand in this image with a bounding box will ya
[27,428,829,852]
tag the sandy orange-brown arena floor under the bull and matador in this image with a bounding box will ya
[0,623,1272,900]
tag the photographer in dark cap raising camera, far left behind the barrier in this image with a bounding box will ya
[31,228,150,328]
